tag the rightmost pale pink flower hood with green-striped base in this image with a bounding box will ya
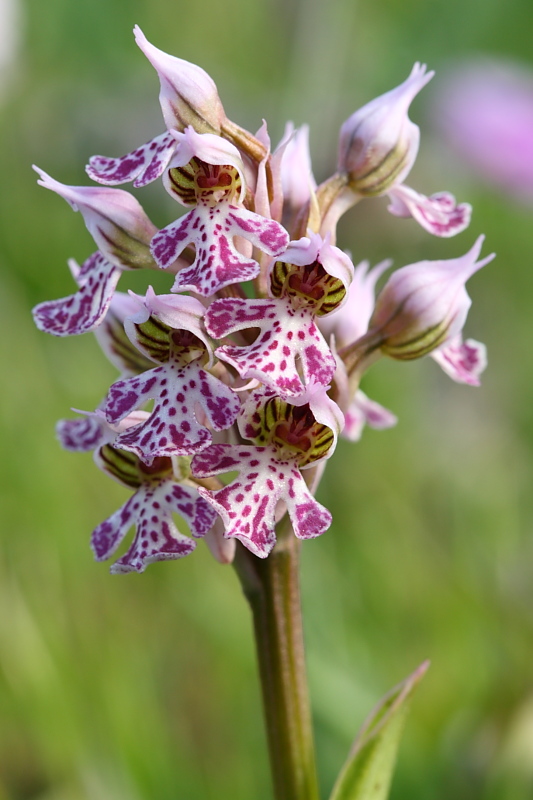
[367,236,494,360]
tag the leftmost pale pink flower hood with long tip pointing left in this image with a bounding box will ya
[34,166,157,269]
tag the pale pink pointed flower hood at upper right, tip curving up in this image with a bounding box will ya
[338,63,434,196]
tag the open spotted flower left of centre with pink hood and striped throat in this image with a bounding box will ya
[106,290,240,464]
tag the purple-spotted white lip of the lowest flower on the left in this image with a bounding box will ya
[91,479,200,573]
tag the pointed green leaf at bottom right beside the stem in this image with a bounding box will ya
[330,661,429,800]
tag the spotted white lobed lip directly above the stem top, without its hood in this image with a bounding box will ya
[191,444,331,558]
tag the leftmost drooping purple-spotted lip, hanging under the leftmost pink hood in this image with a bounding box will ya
[33,252,121,336]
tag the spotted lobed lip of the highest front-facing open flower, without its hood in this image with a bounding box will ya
[150,201,289,297]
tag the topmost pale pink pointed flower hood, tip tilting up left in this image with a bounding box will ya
[133,25,226,134]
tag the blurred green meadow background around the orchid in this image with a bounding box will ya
[0,0,533,800]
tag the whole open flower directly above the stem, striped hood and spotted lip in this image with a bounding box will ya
[191,387,342,558]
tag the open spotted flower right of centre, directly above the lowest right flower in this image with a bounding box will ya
[205,234,353,397]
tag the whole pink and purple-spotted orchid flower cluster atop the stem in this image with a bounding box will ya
[34,28,492,572]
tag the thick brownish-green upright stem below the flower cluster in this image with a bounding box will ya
[235,530,319,800]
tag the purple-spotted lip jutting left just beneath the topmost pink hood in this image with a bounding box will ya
[85,132,177,187]
